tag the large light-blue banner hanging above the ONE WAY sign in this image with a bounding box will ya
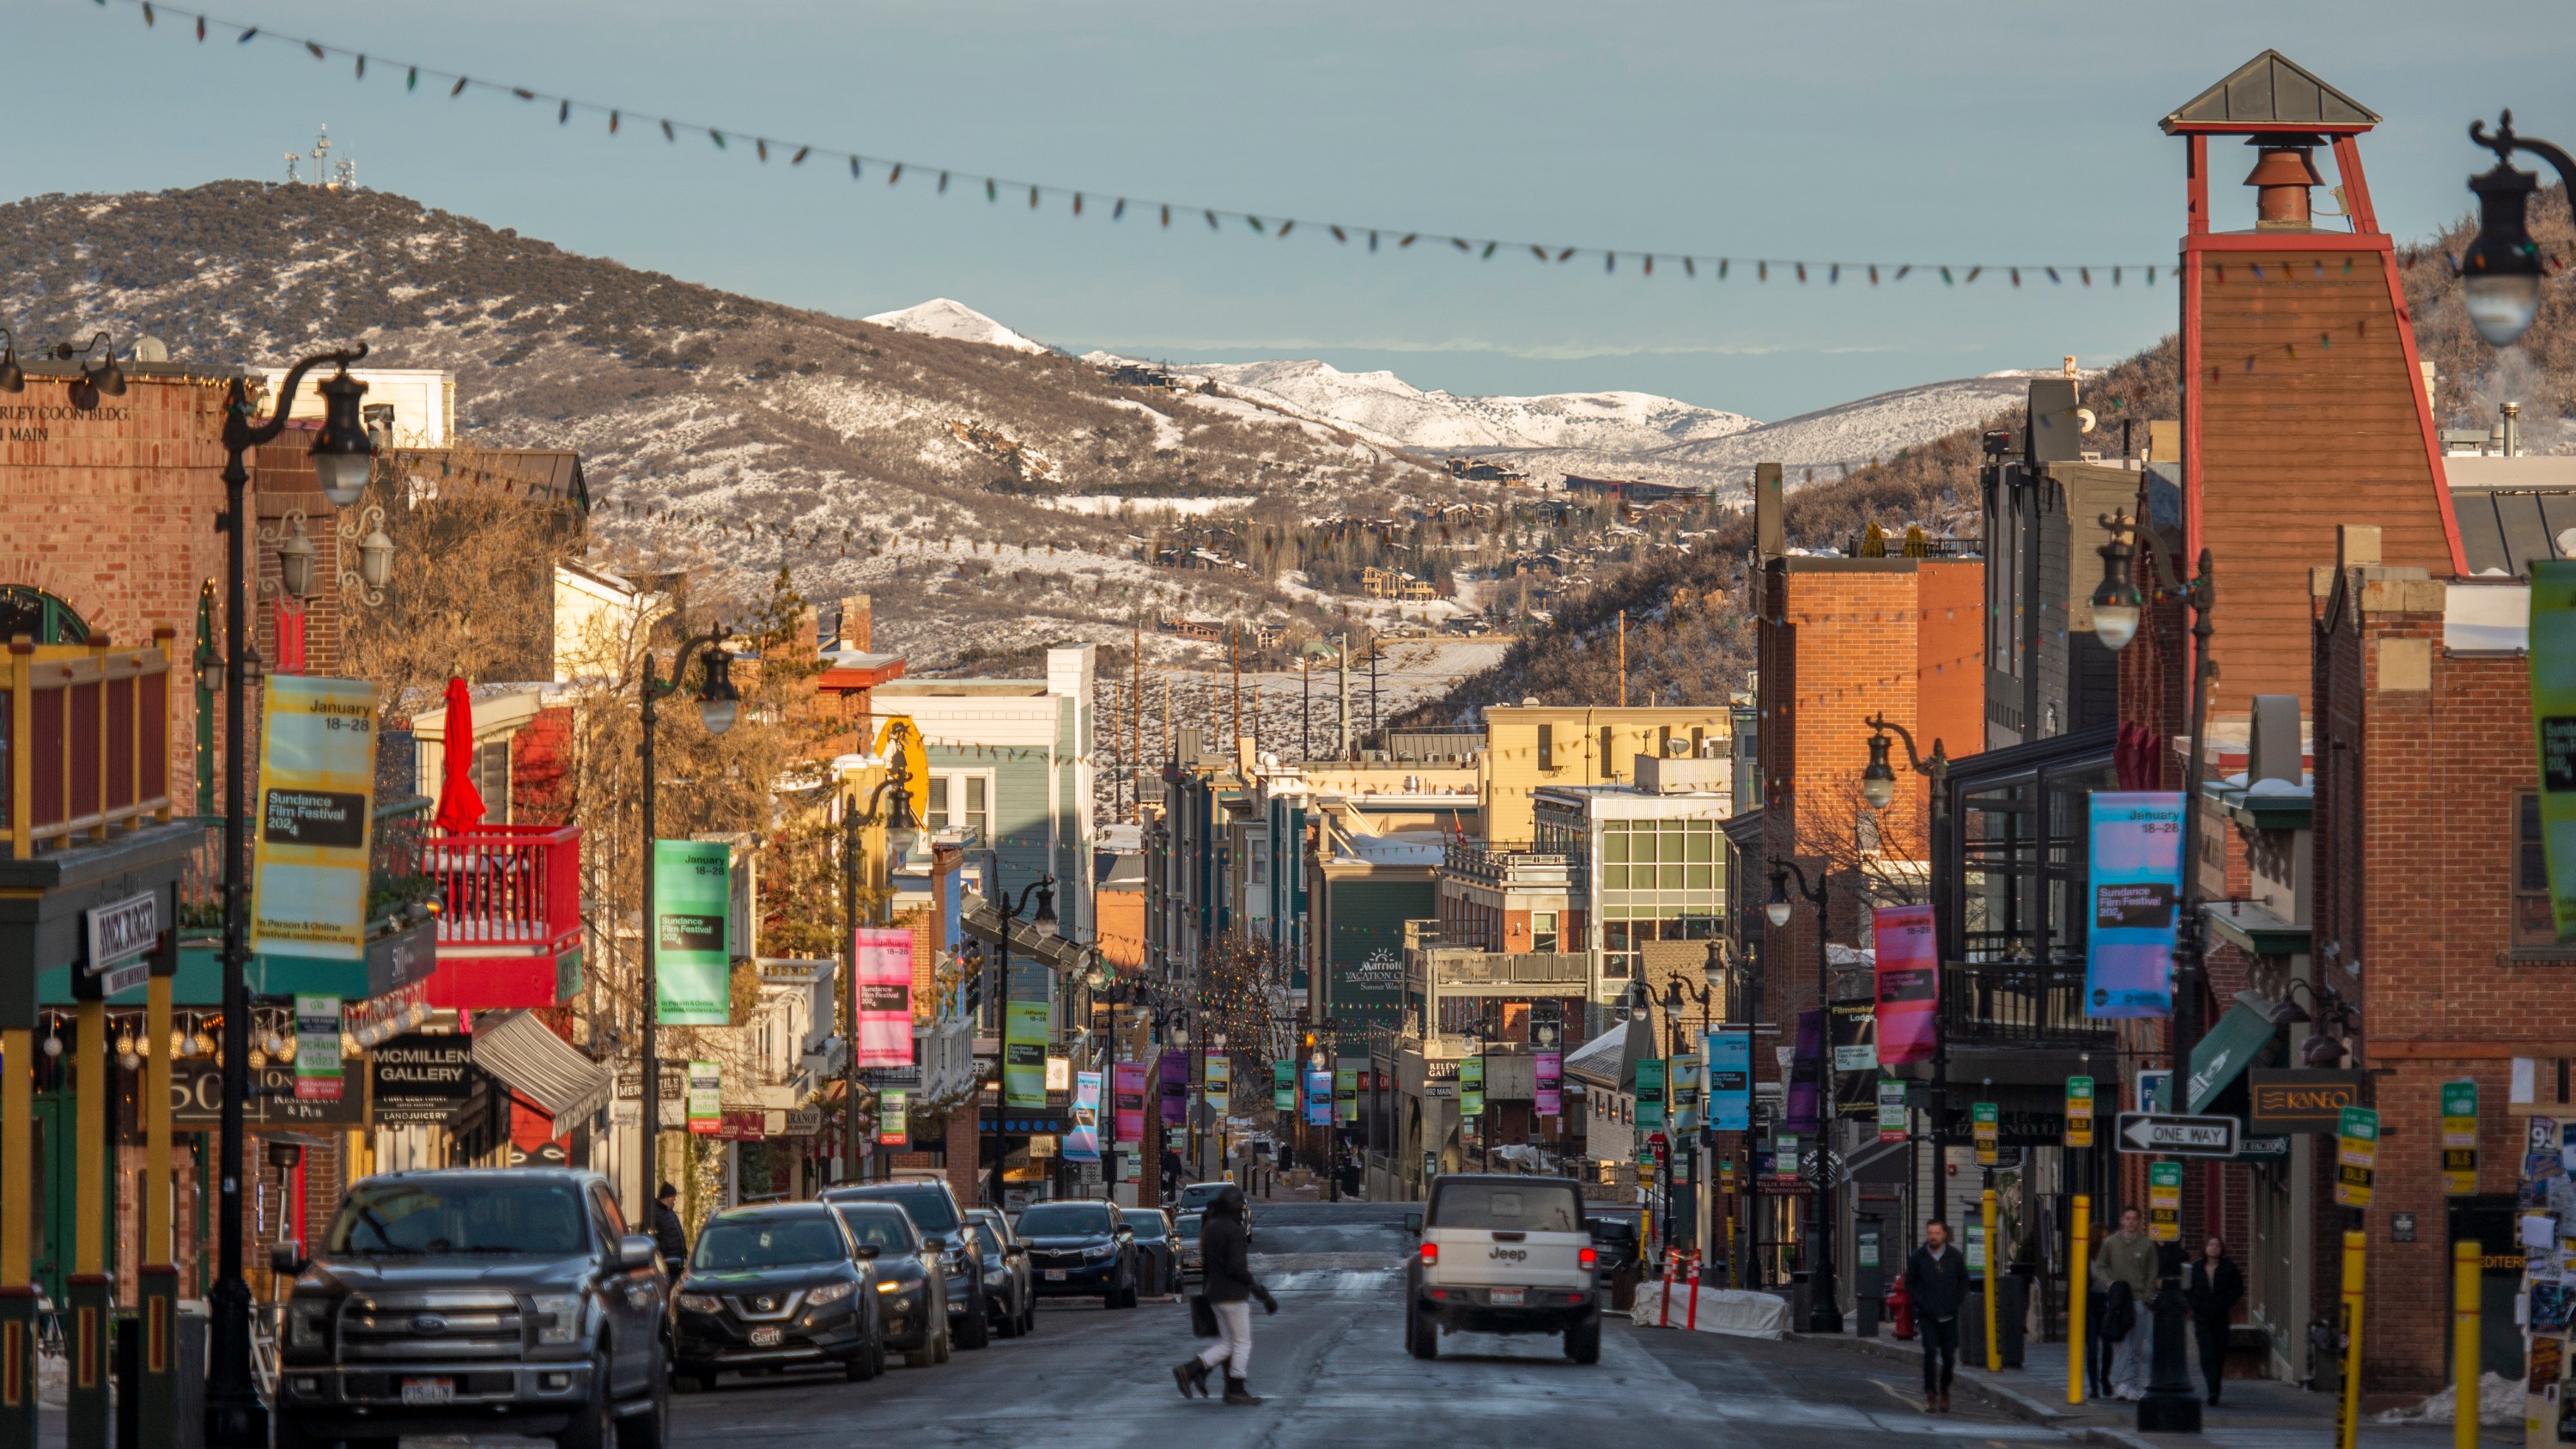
[2084,789,2182,1016]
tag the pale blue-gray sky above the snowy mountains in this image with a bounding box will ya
[0,0,2576,417]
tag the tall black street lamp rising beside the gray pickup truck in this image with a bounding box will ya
[204,332,371,1449]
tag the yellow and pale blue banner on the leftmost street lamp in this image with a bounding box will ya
[250,675,376,959]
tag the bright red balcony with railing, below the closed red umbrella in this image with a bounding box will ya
[420,825,582,1011]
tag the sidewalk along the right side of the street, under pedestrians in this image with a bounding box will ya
[1793,1333,2522,1449]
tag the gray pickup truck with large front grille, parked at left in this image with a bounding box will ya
[273,1168,667,1449]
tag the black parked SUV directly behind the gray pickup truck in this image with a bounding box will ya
[670,1202,886,1392]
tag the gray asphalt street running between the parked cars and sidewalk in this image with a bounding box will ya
[672,1204,2066,1449]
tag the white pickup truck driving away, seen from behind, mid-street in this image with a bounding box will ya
[1404,1173,1602,1364]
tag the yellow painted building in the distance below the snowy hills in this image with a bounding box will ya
[1479,703,1734,851]
